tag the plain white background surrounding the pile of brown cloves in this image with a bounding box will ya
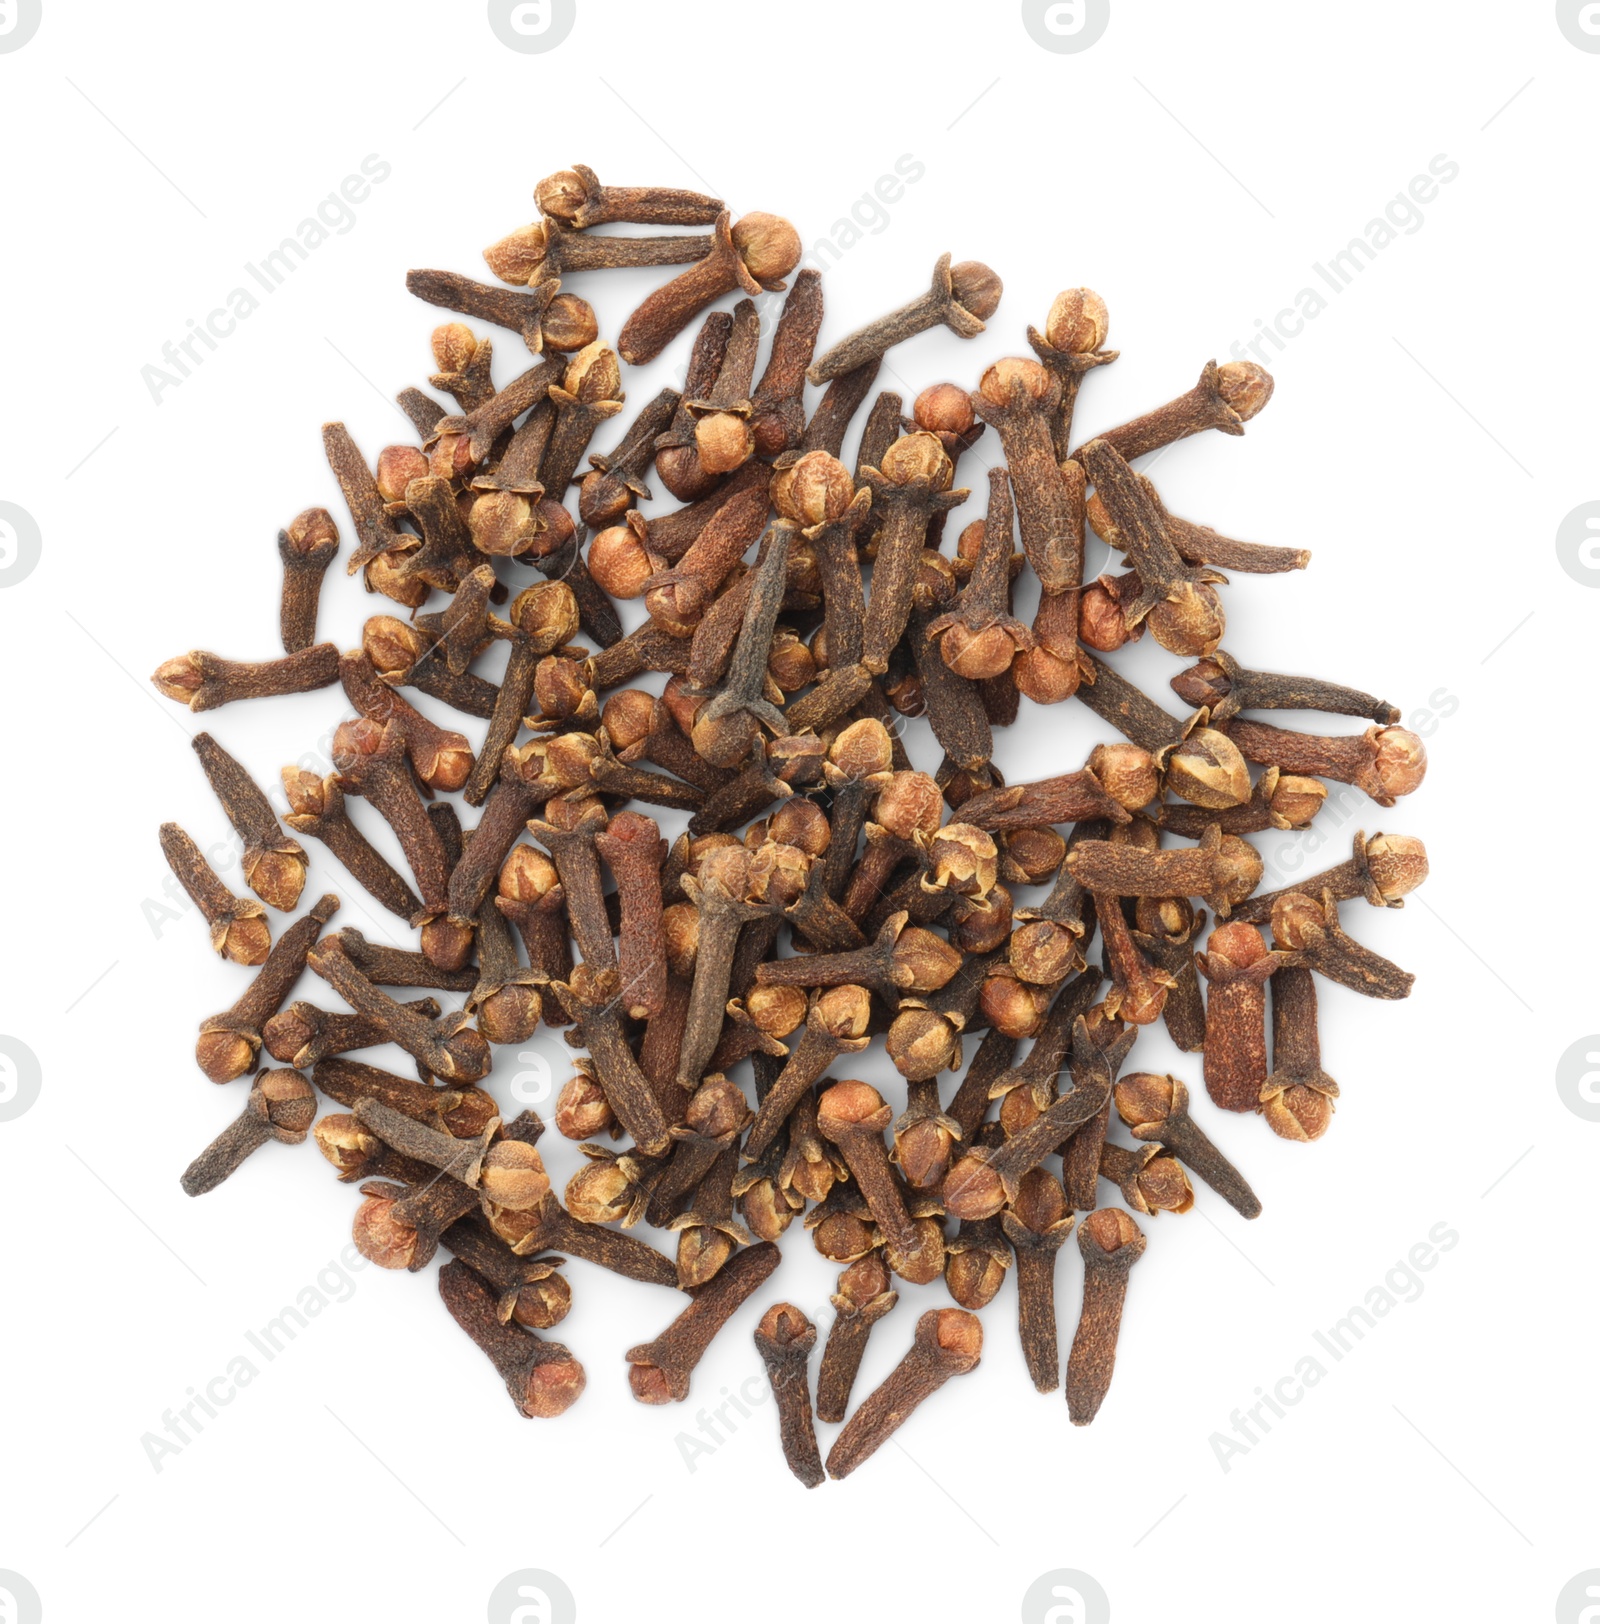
[0,0,1600,1624]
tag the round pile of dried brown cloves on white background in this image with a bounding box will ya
[154,167,1426,1484]
